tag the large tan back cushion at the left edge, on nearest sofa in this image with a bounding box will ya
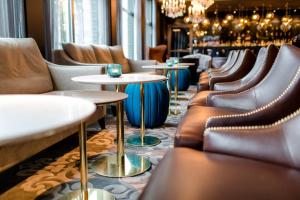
[0,38,53,94]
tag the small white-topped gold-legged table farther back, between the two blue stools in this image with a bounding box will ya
[142,63,188,115]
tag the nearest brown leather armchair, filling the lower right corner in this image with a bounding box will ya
[140,107,300,200]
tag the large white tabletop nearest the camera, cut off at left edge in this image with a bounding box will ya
[0,95,96,146]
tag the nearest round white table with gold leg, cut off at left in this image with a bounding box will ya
[0,95,115,200]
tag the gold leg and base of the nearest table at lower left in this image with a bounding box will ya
[60,122,115,200]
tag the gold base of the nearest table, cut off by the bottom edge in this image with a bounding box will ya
[59,188,116,200]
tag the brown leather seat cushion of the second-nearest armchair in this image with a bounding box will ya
[174,106,242,150]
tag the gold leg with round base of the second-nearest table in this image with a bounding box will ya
[92,102,151,178]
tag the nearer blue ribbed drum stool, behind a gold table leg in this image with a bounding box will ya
[124,82,169,128]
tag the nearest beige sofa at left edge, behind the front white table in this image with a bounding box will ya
[0,38,105,171]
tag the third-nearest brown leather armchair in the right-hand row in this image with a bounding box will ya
[189,45,278,107]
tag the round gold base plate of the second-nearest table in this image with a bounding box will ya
[92,154,151,178]
